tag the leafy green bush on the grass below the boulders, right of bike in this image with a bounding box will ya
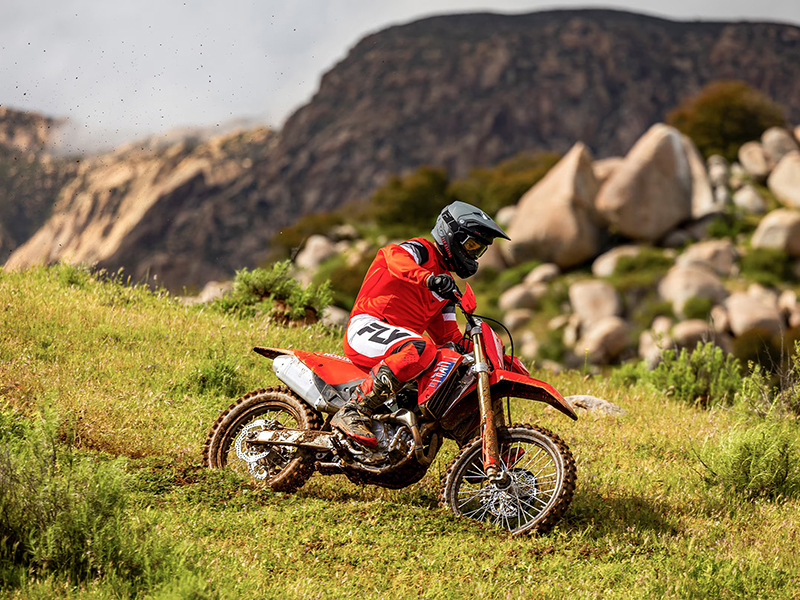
[649,342,742,407]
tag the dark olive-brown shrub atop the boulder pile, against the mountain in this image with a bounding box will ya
[666,81,786,162]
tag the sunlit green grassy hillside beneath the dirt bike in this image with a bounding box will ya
[0,266,800,599]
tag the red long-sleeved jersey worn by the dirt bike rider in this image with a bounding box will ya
[350,238,461,345]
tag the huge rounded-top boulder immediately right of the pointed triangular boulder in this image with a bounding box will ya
[595,124,692,241]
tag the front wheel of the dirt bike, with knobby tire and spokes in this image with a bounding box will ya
[441,425,577,535]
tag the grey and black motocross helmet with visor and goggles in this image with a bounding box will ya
[431,202,510,278]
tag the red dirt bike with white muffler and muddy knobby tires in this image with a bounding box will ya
[203,286,577,534]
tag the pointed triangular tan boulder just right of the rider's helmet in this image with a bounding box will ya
[503,143,600,268]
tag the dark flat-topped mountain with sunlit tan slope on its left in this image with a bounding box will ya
[0,10,800,290]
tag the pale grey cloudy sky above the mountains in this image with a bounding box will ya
[0,0,800,152]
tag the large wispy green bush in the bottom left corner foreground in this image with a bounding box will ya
[0,410,174,588]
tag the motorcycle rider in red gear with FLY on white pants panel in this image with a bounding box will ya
[331,202,509,447]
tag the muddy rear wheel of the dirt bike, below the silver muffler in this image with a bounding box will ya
[203,386,322,492]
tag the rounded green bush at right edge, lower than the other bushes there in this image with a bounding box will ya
[701,421,800,499]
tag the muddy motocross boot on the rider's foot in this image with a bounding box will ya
[331,363,403,447]
